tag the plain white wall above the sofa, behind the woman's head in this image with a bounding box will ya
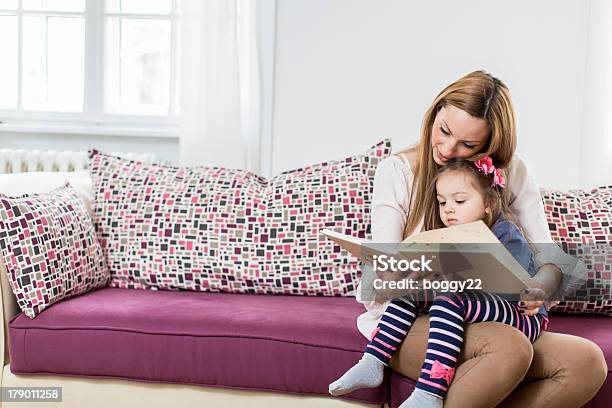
[272,0,612,188]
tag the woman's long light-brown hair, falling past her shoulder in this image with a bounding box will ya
[397,71,516,238]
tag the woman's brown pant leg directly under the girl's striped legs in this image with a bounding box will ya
[390,315,533,408]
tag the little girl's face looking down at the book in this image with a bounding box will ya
[436,171,491,227]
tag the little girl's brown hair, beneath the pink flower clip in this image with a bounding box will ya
[423,159,517,231]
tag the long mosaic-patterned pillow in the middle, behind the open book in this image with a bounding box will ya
[89,140,391,296]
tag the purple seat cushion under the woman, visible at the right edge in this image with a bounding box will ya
[389,313,612,408]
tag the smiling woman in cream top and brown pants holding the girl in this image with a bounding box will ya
[357,71,607,408]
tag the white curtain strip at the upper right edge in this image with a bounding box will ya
[580,0,612,188]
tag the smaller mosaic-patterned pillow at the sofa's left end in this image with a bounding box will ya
[0,183,110,319]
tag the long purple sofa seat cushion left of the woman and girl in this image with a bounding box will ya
[9,288,389,404]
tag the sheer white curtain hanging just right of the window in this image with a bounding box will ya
[180,0,262,173]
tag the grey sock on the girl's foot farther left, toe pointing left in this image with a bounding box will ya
[329,353,385,396]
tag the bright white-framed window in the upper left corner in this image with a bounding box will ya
[0,0,180,137]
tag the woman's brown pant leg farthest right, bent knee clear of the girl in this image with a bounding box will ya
[499,332,608,408]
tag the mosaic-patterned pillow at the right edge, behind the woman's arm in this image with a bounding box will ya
[541,186,612,316]
